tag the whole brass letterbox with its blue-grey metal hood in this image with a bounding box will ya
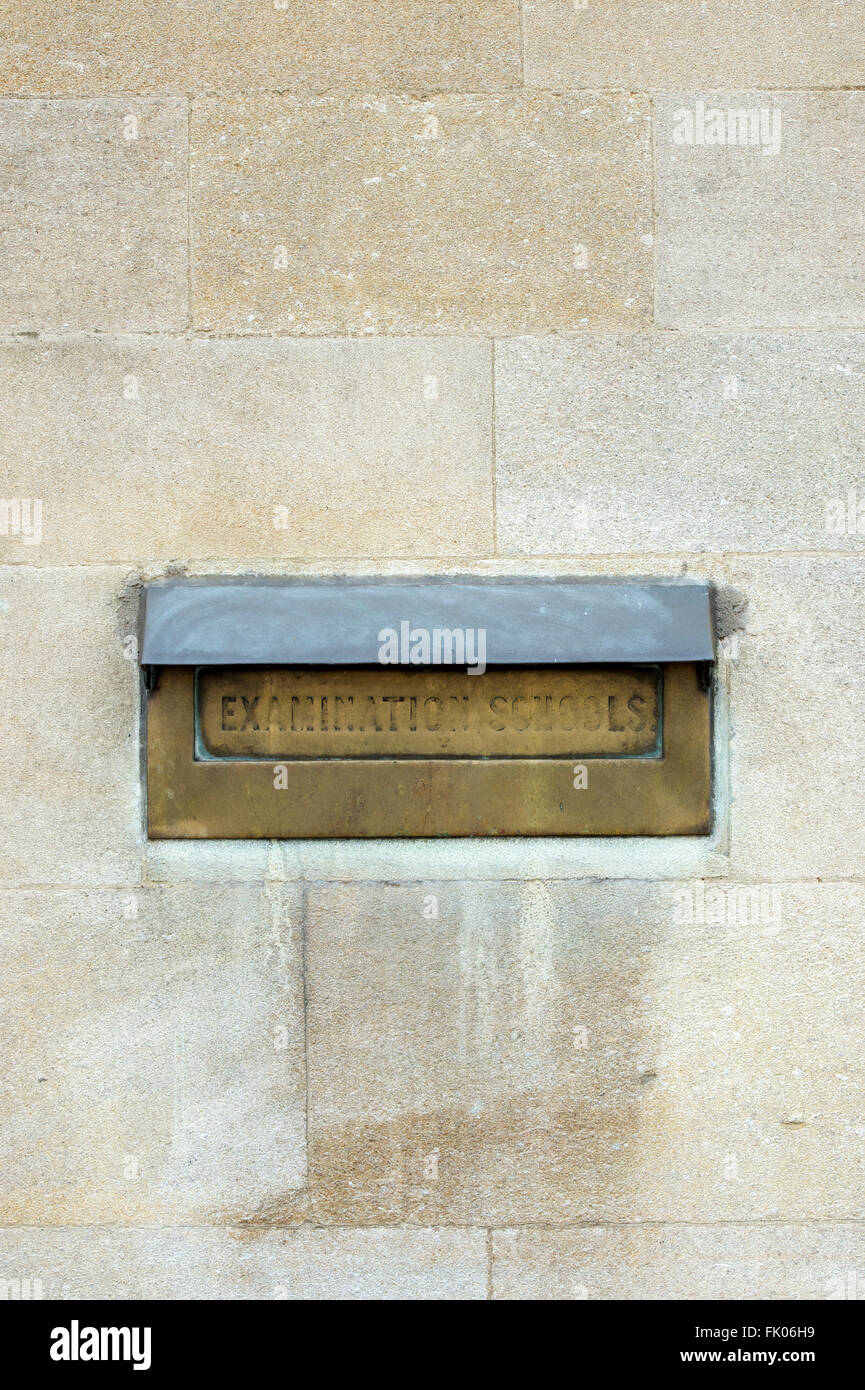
[142,580,712,838]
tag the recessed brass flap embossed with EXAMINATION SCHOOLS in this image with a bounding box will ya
[197,666,658,760]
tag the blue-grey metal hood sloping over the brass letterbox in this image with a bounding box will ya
[140,578,713,666]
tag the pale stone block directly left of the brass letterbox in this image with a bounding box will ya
[0,567,142,885]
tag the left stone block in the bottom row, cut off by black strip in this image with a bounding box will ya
[0,1226,487,1301]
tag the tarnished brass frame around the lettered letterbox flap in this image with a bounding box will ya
[147,663,711,840]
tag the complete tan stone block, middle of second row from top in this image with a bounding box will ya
[192,95,654,334]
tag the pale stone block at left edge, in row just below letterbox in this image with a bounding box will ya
[0,884,306,1225]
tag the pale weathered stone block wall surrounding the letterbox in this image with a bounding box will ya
[0,0,865,1298]
